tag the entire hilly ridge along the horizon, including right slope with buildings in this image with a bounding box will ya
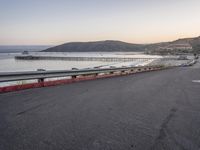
[43,37,200,54]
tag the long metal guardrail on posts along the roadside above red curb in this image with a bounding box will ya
[0,66,162,82]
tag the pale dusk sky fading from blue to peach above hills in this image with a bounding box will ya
[0,0,200,45]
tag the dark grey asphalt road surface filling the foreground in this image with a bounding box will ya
[0,64,200,150]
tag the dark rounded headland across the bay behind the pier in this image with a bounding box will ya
[44,41,144,52]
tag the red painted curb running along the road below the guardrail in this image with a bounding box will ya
[0,68,165,93]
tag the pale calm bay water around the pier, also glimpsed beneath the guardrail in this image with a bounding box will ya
[0,52,158,87]
